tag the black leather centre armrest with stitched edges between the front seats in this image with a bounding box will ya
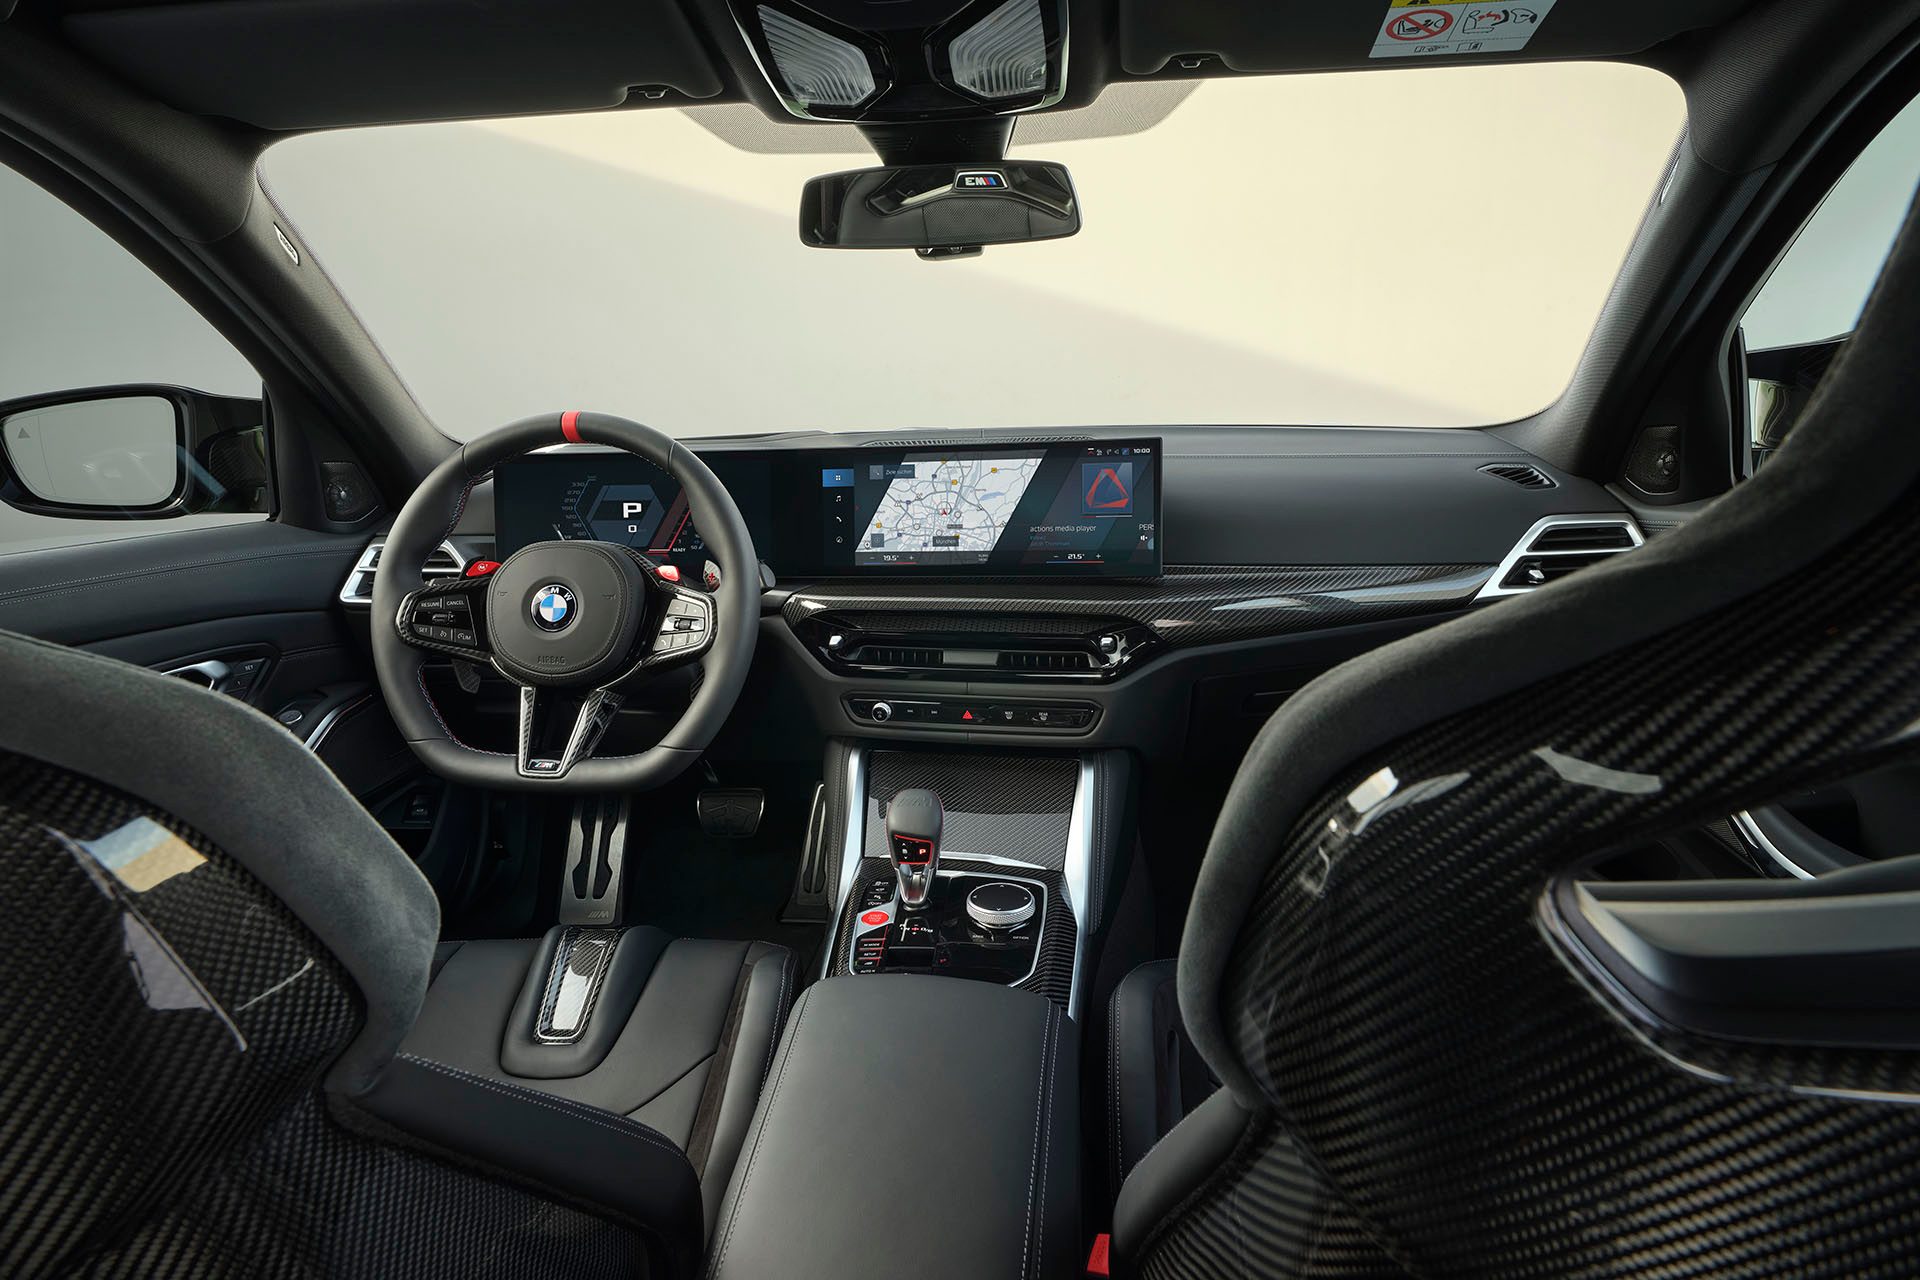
[708,973,1081,1280]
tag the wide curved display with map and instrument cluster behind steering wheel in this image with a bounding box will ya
[493,439,1162,578]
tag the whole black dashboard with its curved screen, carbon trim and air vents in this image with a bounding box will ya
[378,426,1659,766]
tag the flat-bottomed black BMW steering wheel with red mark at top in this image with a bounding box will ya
[372,413,760,791]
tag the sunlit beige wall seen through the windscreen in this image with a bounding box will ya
[263,63,1684,436]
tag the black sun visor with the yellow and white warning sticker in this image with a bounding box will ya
[1119,0,1745,75]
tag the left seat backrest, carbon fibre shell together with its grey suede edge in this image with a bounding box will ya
[0,633,647,1278]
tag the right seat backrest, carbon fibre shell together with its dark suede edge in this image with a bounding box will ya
[1133,189,1920,1276]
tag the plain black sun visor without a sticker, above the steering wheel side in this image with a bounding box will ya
[63,0,722,129]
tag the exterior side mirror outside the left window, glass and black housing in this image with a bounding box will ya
[0,386,271,520]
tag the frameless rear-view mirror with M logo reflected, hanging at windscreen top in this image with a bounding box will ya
[801,159,1079,257]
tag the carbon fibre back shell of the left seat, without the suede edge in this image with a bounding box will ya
[0,752,647,1280]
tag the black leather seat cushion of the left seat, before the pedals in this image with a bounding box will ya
[399,927,799,1232]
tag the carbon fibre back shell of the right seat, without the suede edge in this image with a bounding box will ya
[1139,493,1920,1276]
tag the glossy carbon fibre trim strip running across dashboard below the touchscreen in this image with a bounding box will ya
[781,564,1494,649]
